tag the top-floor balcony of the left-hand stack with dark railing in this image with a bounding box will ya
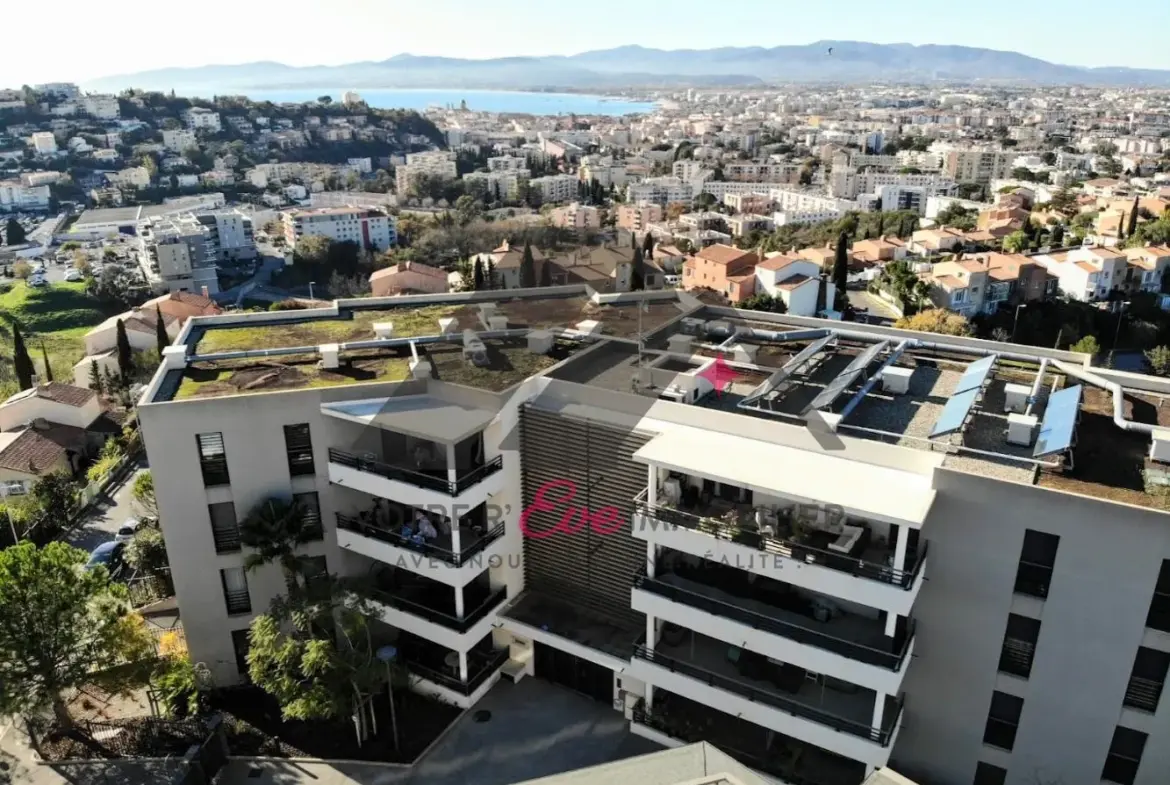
[329,448,503,509]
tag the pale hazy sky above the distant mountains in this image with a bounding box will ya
[9,0,1170,85]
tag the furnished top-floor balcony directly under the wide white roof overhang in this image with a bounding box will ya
[633,491,927,615]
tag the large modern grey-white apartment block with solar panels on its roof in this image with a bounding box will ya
[139,287,1170,785]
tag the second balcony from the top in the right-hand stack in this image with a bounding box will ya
[632,570,914,694]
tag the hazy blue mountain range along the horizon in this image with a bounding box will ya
[84,41,1170,94]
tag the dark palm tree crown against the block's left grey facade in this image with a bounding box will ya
[240,497,321,588]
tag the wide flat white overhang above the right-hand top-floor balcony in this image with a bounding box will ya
[633,426,935,526]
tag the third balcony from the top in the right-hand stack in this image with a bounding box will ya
[631,631,902,766]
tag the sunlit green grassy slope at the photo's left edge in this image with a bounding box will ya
[0,281,106,398]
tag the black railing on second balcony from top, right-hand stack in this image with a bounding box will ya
[634,567,914,670]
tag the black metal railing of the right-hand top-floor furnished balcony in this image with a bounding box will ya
[634,500,927,590]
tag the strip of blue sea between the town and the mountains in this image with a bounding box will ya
[232,89,655,116]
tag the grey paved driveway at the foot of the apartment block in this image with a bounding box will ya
[220,679,662,785]
